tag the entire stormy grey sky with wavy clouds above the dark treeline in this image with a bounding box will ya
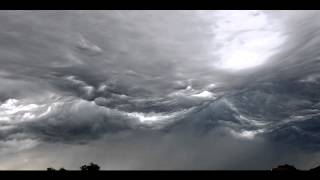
[0,11,320,170]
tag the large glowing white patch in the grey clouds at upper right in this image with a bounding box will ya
[212,11,285,71]
